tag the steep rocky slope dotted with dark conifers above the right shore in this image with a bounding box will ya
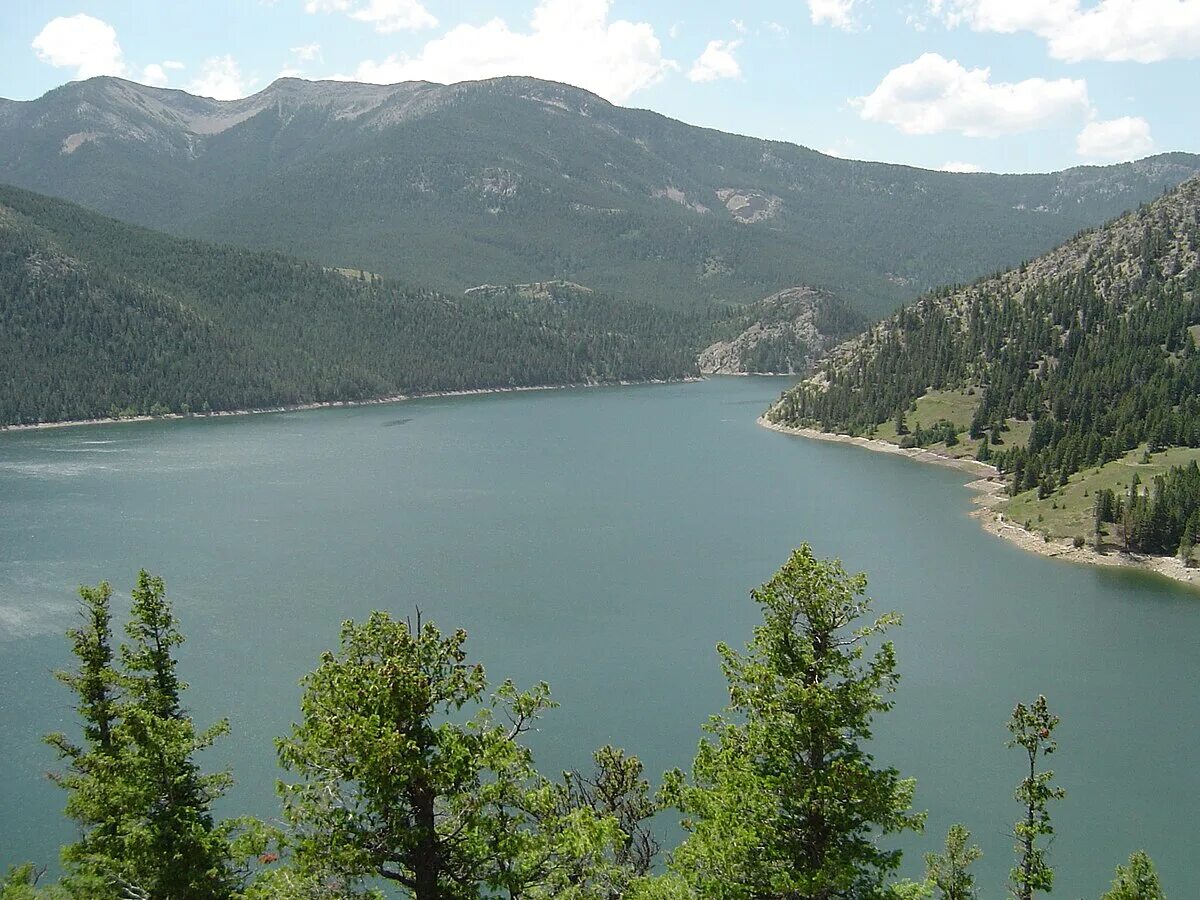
[769,180,1200,525]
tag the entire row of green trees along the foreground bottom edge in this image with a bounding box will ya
[11,561,1163,900]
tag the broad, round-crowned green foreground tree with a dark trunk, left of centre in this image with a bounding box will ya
[278,612,566,900]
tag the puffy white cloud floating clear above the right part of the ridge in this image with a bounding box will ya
[852,53,1090,138]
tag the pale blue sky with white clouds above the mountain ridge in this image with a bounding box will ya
[0,0,1200,172]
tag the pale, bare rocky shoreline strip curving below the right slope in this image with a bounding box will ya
[758,415,1200,588]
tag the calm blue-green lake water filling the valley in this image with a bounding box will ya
[0,378,1200,898]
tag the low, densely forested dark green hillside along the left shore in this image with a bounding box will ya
[0,185,710,424]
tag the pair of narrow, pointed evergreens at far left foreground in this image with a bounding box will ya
[47,571,239,900]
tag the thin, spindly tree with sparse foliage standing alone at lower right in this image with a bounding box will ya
[1008,696,1067,900]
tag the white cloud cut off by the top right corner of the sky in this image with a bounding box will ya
[930,0,1200,62]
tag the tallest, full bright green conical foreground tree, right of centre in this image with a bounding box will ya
[664,545,924,900]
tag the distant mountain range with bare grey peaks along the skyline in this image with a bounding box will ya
[0,77,1200,314]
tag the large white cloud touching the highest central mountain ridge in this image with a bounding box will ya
[343,0,678,103]
